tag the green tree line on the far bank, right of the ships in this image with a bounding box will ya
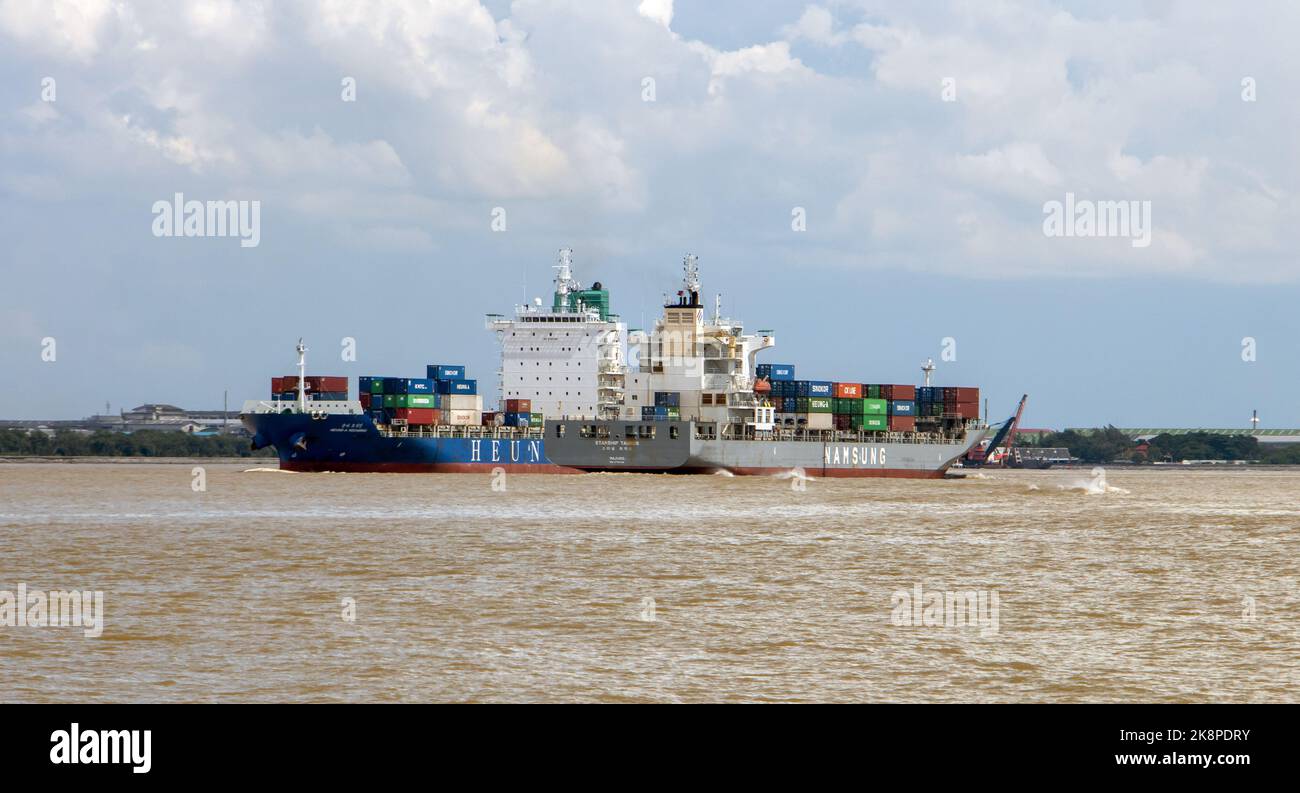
[1018,425,1300,465]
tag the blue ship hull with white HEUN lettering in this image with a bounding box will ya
[242,413,566,473]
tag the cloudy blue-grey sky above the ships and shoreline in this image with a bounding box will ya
[0,0,1300,428]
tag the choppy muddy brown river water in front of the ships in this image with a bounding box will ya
[0,462,1300,702]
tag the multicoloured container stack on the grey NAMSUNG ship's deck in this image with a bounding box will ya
[759,364,979,432]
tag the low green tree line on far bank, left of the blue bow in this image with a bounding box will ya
[0,429,276,458]
